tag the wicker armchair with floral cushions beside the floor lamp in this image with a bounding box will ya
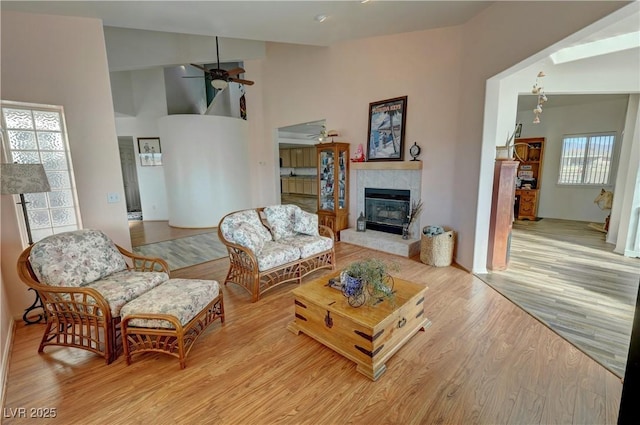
[18,229,169,364]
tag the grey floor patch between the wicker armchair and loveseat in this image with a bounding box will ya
[133,232,227,270]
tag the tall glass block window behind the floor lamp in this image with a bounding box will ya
[1,101,81,242]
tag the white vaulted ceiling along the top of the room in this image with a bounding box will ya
[0,0,493,46]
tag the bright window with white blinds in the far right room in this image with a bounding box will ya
[558,133,616,186]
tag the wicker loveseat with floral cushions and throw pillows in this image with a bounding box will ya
[218,205,335,302]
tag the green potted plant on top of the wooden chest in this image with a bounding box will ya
[341,258,399,307]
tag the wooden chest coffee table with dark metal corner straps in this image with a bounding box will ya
[287,272,431,381]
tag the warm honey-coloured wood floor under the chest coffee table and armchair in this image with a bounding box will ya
[3,224,622,424]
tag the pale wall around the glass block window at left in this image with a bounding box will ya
[0,11,131,317]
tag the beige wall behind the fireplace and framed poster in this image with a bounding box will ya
[256,28,461,234]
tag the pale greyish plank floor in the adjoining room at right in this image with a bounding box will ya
[480,218,640,377]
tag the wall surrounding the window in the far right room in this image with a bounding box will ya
[517,94,628,223]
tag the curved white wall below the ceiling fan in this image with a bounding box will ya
[158,115,251,228]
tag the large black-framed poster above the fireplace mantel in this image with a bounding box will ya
[367,96,407,161]
